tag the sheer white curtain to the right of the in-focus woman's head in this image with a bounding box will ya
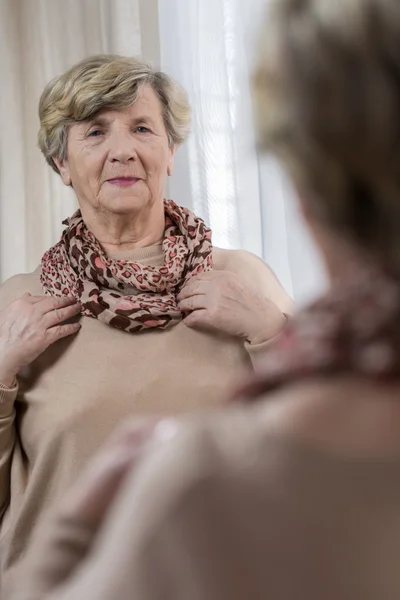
[159,0,326,304]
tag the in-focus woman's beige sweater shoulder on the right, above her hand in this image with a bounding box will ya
[214,248,294,315]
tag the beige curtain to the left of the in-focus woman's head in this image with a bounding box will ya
[0,0,141,281]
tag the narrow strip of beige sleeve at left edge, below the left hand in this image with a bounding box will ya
[0,384,18,521]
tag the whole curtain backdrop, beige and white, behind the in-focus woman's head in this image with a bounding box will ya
[0,0,326,305]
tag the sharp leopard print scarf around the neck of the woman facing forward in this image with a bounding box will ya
[41,200,213,333]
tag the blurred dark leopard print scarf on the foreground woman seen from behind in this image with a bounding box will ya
[234,266,400,400]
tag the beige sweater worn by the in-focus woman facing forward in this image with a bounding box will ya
[0,246,292,599]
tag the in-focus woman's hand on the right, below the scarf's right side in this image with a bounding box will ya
[177,271,286,344]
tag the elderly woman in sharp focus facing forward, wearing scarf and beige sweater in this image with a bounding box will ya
[0,56,292,583]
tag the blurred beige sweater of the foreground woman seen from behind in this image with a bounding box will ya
[12,400,400,600]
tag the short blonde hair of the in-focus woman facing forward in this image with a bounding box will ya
[38,54,191,173]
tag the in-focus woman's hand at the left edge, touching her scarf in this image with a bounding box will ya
[0,294,81,387]
